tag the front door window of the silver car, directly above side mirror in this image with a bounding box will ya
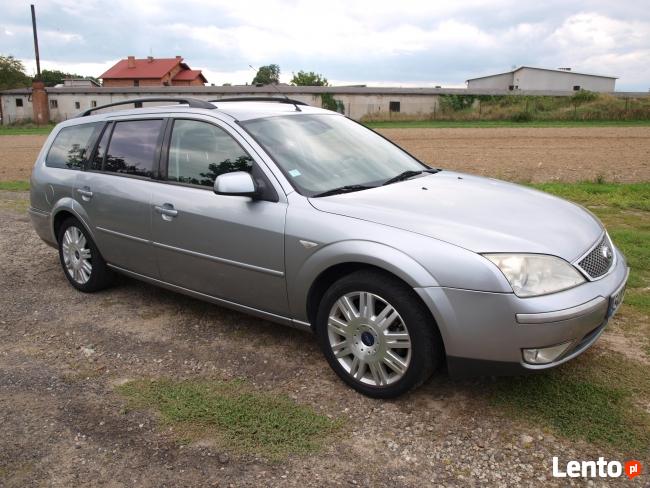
[167,119,253,187]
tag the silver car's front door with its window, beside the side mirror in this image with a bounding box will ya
[151,119,288,315]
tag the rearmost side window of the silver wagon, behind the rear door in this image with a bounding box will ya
[45,123,99,169]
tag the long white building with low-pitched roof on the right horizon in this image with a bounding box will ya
[466,66,617,92]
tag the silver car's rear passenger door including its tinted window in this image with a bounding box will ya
[73,118,166,277]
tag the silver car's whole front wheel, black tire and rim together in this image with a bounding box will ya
[316,270,444,398]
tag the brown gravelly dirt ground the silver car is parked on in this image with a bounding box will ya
[0,192,644,488]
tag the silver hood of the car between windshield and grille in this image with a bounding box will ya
[309,171,603,261]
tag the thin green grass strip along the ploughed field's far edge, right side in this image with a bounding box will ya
[364,120,650,129]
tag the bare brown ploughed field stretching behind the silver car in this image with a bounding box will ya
[0,127,650,182]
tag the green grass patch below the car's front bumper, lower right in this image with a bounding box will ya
[490,353,650,456]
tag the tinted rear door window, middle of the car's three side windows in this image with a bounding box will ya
[104,120,163,177]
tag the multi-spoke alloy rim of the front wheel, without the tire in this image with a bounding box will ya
[327,291,411,386]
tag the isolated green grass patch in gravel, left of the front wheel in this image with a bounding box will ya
[118,379,340,460]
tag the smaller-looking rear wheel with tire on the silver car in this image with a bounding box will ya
[57,217,113,293]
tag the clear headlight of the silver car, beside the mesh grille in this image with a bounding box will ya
[484,254,585,297]
